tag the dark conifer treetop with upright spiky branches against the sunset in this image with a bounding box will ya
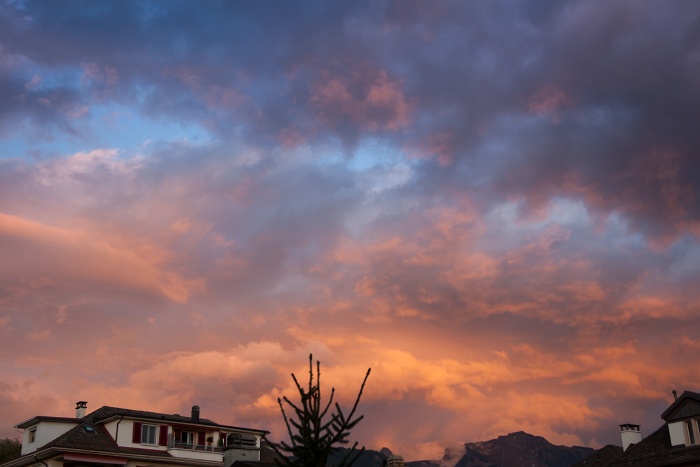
[264,355,371,467]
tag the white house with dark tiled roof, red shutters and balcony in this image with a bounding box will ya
[1,401,274,467]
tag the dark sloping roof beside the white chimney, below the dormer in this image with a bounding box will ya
[594,423,700,467]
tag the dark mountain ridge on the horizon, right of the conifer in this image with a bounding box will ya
[329,431,595,467]
